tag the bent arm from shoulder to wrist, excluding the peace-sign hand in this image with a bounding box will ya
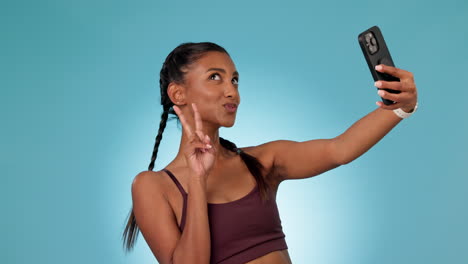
[132,172,210,264]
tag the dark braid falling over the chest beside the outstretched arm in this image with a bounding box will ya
[219,137,270,201]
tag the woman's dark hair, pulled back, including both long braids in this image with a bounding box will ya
[122,42,269,251]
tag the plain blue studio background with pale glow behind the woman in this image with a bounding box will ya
[0,0,468,264]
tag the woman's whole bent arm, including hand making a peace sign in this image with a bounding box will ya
[132,104,217,264]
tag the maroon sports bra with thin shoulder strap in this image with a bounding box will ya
[162,169,288,264]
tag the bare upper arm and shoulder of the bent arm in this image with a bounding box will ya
[132,171,181,263]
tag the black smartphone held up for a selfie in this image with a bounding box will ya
[358,26,400,105]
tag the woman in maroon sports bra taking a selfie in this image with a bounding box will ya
[123,42,417,264]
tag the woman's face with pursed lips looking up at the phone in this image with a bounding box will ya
[184,51,240,127]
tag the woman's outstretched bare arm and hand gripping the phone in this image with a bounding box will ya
[265,65,417,181]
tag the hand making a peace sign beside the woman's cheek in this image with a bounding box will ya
[173,103,216,180]
